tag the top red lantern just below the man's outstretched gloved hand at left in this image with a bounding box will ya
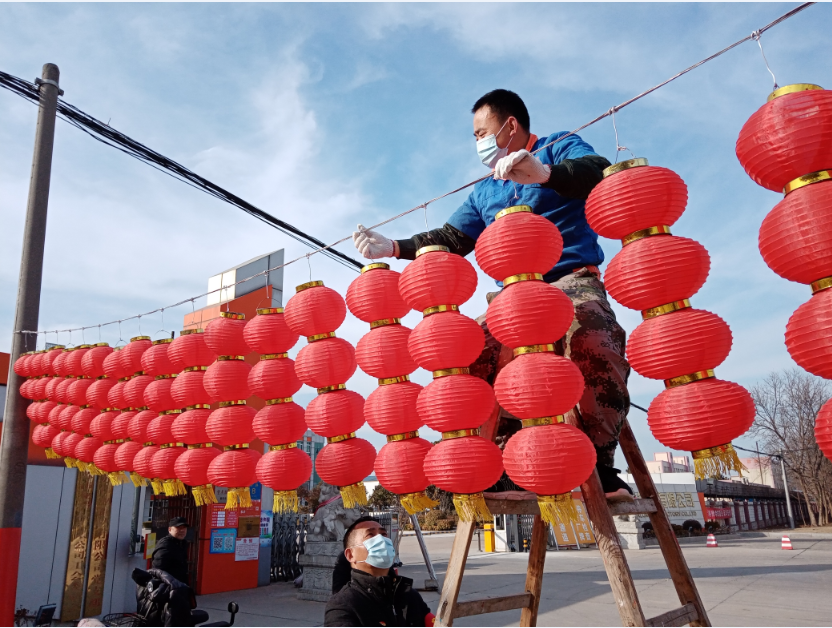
[346,262,410,323]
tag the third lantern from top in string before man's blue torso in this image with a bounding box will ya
[494,353,584,419]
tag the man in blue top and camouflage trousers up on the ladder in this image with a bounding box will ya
[353,89,632,499]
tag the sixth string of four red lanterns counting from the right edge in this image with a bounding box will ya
[285,281,376,508]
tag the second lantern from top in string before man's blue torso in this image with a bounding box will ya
[486,282,575,348]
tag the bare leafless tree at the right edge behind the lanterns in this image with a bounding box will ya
[749,369,832,526]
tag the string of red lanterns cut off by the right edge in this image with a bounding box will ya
[737,83,832,460]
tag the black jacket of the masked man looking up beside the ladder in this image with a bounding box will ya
[324,569,430,626]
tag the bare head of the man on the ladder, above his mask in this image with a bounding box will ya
[471,89,530,158]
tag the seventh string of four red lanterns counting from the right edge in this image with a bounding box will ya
[245,307,312,513]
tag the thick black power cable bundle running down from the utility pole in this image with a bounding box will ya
[0,71,363,270]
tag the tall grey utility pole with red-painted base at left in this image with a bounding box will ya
[0,63,63,626]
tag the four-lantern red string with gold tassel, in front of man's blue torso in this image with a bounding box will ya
[476,205,596,525]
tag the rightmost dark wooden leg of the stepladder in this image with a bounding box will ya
[619,420,711,626]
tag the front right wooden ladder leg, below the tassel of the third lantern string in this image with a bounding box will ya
[564,409,645,626]
